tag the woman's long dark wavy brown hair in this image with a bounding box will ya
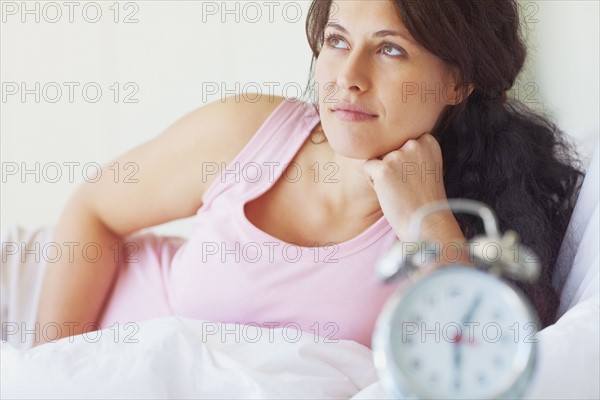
[306,0,584,327]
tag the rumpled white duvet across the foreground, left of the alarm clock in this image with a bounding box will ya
[1,317,377,399]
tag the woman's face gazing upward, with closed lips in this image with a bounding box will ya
[315,0,456,159]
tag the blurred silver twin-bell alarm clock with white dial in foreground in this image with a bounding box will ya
[372,199,540,399]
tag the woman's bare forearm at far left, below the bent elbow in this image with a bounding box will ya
[34,191,123,345]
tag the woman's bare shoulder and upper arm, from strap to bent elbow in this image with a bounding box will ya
[79,96,283,235]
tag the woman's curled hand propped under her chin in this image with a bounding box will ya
[363,133,453,240]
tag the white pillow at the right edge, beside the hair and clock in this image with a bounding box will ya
[527,148,600,399]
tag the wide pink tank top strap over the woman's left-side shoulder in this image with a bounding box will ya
[201,98,320,209]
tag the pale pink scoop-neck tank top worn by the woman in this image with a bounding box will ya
[101,99,404,347]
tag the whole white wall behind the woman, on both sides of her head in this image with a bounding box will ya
[0,0,599,235]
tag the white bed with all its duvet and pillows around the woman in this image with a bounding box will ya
[0,149,600,399]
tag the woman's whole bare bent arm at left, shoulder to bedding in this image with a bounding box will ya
[34,96,282,345]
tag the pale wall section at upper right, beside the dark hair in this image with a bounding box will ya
[513,0,600,164]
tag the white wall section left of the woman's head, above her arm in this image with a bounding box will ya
[0,1,311,238]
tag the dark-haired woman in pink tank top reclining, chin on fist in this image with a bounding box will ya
[31,0,583,345]
